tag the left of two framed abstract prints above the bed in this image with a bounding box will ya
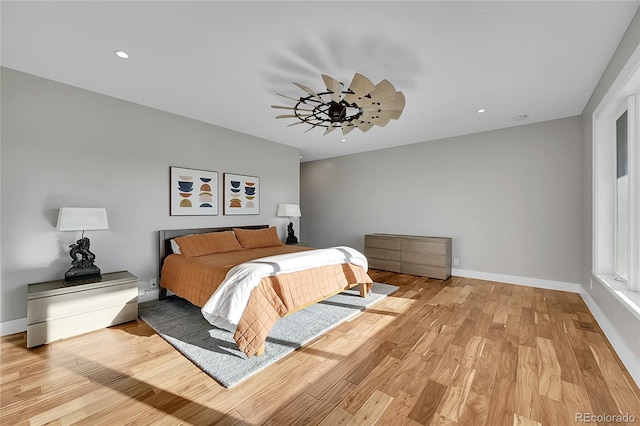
[171,167,218,216]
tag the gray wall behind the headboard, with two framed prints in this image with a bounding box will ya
[0,68,300,322]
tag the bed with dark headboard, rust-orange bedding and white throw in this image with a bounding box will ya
[159,225,372,357]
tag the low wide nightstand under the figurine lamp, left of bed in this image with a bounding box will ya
[27,271,138,348]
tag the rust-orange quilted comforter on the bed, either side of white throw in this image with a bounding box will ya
[161,246,372,356]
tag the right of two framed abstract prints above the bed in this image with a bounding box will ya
[223,173,260,215]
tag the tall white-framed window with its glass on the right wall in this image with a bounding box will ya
[593,48,640,296]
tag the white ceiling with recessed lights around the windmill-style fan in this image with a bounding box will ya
[0,0,640,161]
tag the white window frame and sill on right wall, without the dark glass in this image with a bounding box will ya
[592,47,640,318]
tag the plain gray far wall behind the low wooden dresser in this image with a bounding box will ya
[300,117,582,283]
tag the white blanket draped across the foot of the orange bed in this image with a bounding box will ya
[202,246,368,332]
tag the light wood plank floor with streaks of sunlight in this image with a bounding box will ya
[0,271,640,426]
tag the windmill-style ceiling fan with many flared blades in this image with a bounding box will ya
[271,73,405,135]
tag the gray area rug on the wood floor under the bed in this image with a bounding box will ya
[138,283,399,388]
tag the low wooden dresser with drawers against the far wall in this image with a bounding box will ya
[364,234,451,280]
